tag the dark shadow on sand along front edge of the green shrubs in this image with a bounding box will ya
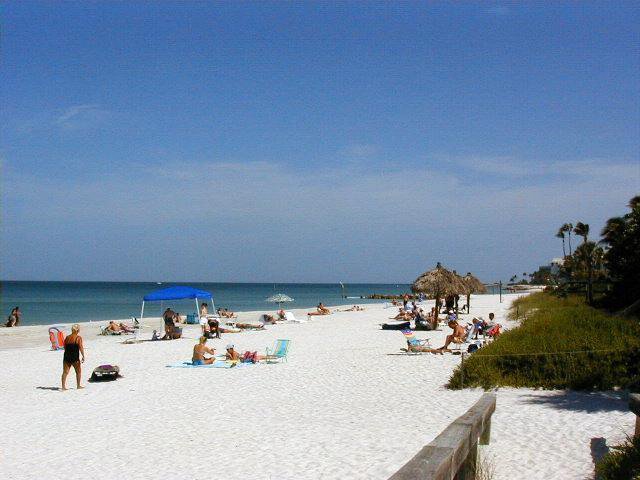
[523,390,629,413]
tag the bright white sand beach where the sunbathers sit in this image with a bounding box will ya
[0,295,635,480]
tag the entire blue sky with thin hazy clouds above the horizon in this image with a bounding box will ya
[0,2,640,282]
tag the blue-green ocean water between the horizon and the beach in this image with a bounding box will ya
[0,281,410,325]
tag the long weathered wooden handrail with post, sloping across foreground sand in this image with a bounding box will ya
[389,393,496,480]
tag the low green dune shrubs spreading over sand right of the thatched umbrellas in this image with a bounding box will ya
[448,293,640,390]
